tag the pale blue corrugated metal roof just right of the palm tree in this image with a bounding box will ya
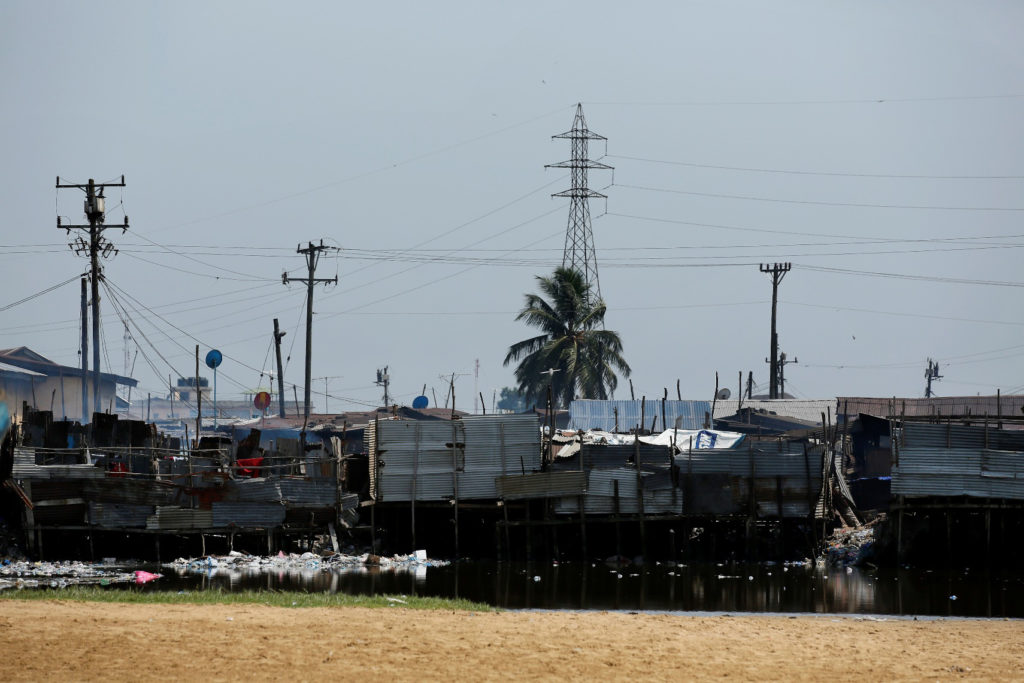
[569,398,711,432]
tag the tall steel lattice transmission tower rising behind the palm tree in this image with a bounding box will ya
[545,104,612,299]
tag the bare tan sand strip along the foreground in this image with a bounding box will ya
[0,600,1024,681]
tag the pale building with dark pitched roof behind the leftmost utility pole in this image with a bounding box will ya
[0,346,138,421]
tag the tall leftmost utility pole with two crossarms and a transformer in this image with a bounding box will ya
[56,175,128,421]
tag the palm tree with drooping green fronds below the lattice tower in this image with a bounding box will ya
[505,267,631,408]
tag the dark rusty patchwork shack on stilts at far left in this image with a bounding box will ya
[7,409,358,556]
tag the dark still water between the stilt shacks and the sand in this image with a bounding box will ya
[130,561,1024,618]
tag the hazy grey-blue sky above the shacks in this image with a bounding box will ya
[0,0,1024,412]
